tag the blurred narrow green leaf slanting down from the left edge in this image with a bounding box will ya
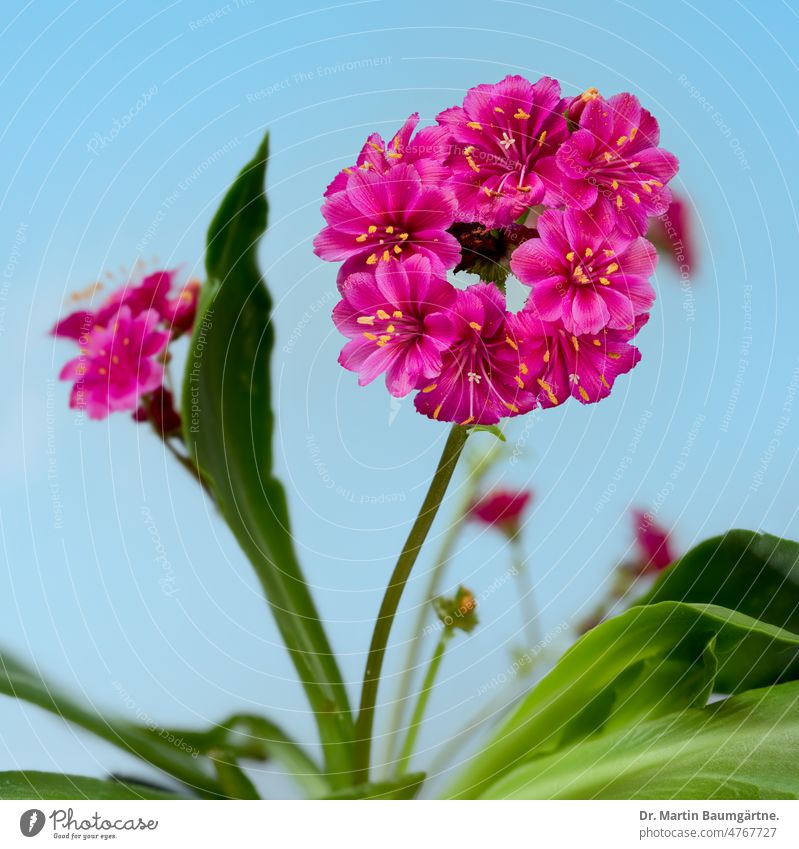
[0,653,219,796]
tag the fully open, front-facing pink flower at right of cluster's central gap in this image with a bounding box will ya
[511,210,657,335]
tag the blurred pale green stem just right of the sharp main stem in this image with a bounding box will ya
[386,443,500,764]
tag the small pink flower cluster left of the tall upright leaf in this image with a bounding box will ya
[51,270,199,422]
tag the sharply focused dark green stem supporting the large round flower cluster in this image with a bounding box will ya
[355,425,469,784]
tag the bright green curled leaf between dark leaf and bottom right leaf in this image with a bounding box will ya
[450,602,799,796]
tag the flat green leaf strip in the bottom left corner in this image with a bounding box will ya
[0,771,180,799]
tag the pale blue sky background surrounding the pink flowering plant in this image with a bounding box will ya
[0,0,799,793]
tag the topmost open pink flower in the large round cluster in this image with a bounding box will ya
[438,76,568,227]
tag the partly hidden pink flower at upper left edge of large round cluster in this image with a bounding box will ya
[325,112,449,197]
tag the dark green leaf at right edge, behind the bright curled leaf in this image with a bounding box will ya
[636,531,799,634]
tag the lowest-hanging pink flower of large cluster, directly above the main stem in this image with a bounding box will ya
[414,283,539,425]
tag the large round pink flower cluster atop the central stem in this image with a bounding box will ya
[314,76,678,425]
